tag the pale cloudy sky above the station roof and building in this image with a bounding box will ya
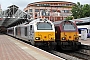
[0,0,90,10]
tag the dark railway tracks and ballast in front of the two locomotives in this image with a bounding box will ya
[50,45,90,60]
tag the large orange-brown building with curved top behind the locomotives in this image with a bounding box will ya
[24,1,75,21]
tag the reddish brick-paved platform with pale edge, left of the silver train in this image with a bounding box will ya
[0,34,64,60]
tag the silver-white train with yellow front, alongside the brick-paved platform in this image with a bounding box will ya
[7,18,56,48]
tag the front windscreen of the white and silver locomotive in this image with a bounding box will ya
[37,22,52,30]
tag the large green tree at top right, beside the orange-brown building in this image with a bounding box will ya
[71,2,90,19]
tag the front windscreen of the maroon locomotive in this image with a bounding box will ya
[62,21,76,31]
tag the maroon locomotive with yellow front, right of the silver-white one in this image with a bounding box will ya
[54,20,81,50]
